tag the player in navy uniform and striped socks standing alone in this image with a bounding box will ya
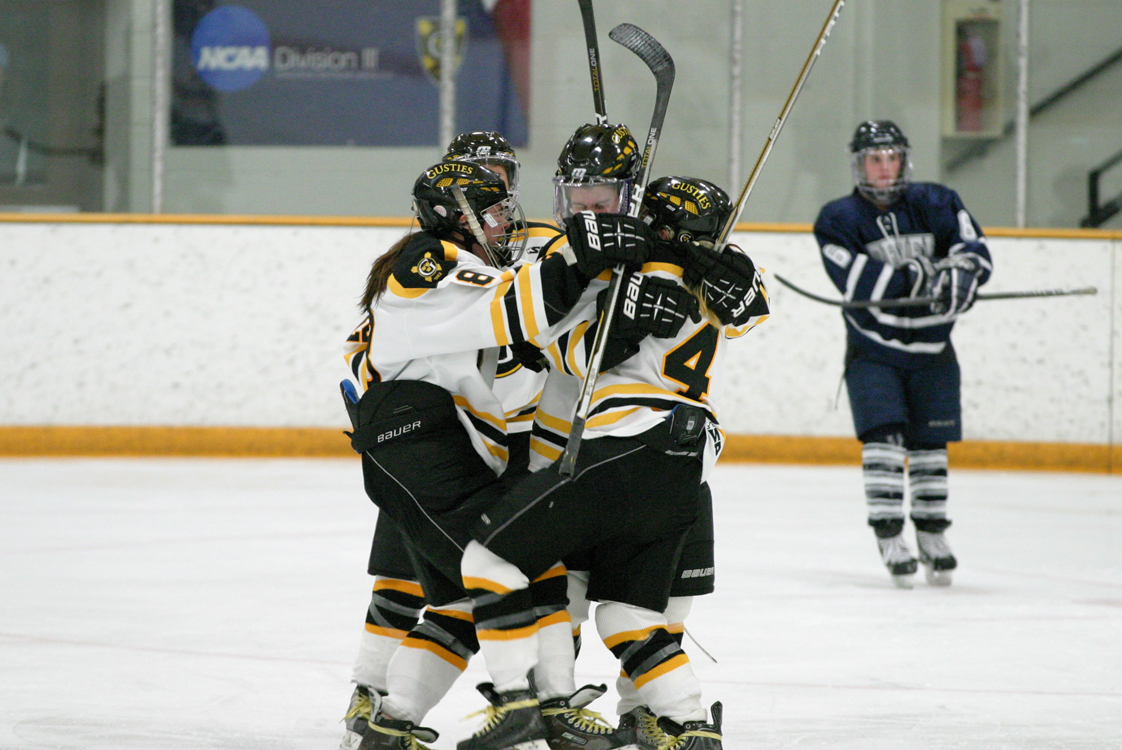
[815,120,993,587]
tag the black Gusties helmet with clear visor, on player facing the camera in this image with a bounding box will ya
[553,124,642,226]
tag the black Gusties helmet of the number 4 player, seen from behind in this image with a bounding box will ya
[640,176,733,243]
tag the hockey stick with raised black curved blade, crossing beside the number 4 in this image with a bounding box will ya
[560,24,674,476]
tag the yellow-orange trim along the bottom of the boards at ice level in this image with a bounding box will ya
[0,426,1122,474]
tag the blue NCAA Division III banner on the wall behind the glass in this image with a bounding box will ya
[171,0,532,146]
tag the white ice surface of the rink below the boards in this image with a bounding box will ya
[0,459,1122,750]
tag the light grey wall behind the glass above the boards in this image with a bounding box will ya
[105,0,1122,227]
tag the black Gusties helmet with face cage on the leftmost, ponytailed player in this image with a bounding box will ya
[413,161,526,268]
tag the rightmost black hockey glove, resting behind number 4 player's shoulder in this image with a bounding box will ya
[682,243,769,326]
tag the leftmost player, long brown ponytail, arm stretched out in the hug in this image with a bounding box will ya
[336,161,646,748]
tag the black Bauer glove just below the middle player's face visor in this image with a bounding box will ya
[567,211,654,278]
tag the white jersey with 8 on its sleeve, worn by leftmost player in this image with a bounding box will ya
[344,232,569,474]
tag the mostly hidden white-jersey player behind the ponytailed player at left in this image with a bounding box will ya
[340,131,560,750]
